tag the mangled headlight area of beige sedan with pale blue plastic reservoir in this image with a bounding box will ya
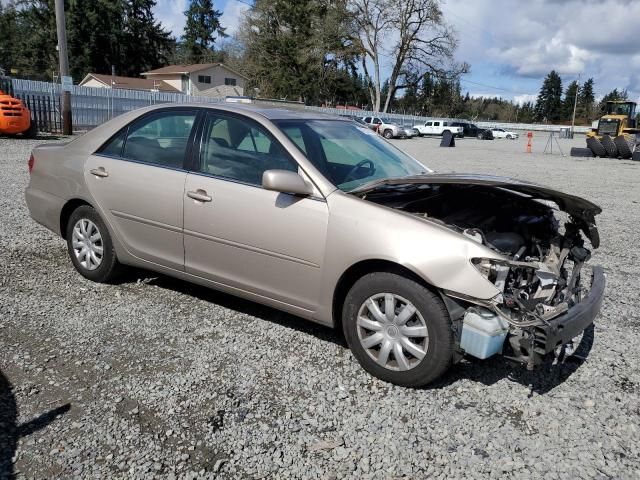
[460,223,601,368]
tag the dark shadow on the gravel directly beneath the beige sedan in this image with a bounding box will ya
[122,270,594,396]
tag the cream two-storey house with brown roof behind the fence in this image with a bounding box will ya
[142,63,248,97]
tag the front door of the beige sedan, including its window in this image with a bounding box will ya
[184,112,328,311]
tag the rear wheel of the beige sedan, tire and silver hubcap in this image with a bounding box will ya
[66,205,122,283]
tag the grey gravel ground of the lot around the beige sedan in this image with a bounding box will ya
[0,132,640,479]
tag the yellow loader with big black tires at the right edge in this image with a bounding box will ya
[571,100,640,160]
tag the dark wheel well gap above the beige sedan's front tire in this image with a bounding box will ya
[331,260,436,329]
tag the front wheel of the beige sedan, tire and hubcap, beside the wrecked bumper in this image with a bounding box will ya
[342,272,453,387]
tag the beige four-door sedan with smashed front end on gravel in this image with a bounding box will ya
[25,104,605,386]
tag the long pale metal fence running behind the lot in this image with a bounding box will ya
[12,79,589,133]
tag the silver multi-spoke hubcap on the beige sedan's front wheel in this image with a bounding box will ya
[357,293,429,371]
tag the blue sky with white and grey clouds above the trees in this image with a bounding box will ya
[155,0,640,102]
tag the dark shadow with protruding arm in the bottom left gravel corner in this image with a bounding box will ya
[0,370,71,480]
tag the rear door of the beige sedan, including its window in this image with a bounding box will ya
[85,108,198,270]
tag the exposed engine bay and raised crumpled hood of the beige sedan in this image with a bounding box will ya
[362,175,600,367]
